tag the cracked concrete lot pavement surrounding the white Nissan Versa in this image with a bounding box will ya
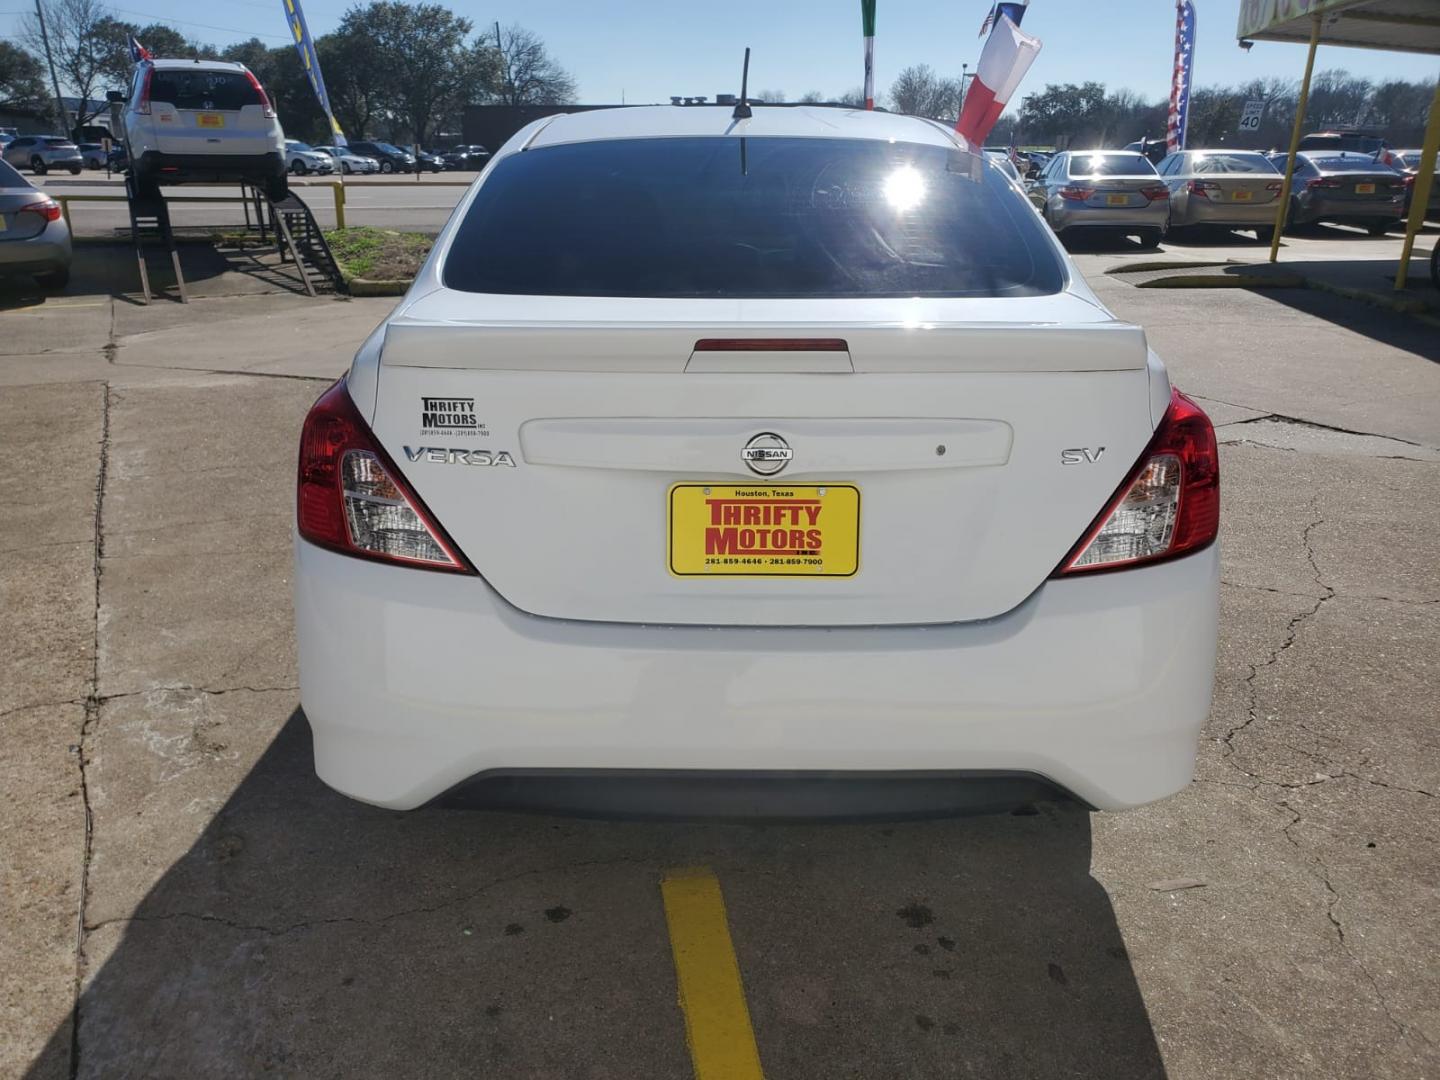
[0,239,1440,1079]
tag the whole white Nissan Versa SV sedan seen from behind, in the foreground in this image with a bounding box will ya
[295,107,1220,815]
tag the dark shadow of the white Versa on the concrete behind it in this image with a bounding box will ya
[27,710,1165,1080]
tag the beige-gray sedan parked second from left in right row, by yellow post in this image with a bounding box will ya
[1159,150,1283,242]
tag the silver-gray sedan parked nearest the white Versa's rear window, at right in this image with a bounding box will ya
[1030,150,1169,248]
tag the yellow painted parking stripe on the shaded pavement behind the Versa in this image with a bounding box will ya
[660,867,765,1080]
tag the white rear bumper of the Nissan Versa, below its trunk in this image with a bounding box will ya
[295,541,1218,809]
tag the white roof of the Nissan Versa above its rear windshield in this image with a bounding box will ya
[527,105,965,147]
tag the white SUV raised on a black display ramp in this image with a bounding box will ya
[117,60,288,197]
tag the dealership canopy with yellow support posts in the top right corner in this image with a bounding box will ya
[1236,0,1440,289]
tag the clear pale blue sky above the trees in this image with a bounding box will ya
[0,0,1440,102]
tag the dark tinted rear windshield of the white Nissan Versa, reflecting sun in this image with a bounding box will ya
[444,137,1064,298]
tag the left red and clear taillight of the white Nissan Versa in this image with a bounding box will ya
[295,379,474,573]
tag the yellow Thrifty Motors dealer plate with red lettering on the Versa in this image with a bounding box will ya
[670,484,860,577]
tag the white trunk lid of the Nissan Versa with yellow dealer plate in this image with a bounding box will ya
[361,291,1153,625]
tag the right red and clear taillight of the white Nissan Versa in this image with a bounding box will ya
[1056,389,1220,576]
